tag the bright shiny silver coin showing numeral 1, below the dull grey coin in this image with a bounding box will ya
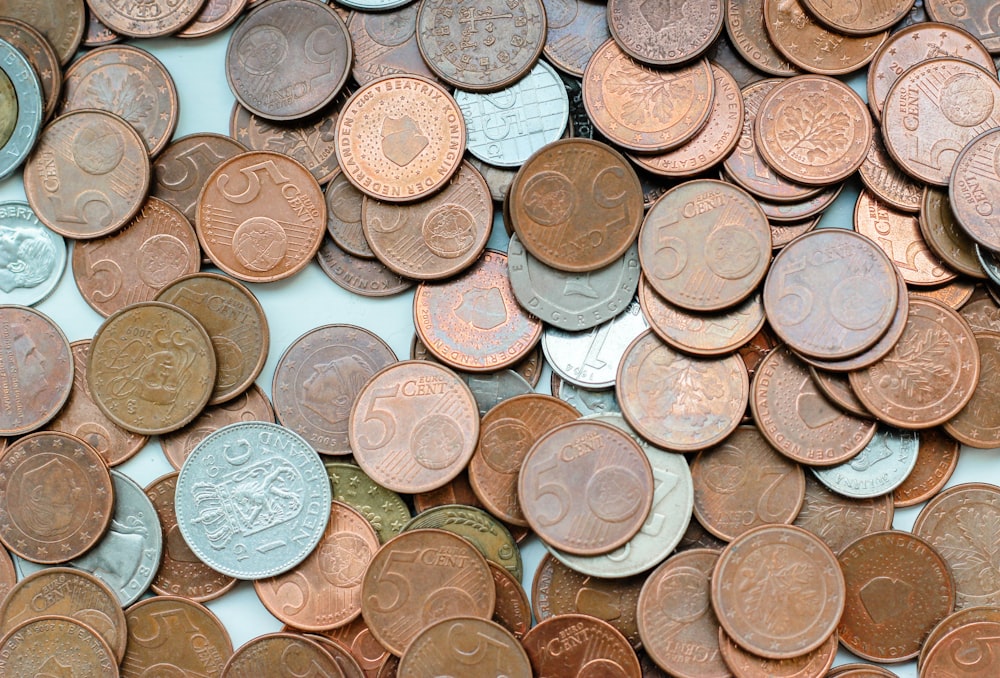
[542,300,649,389]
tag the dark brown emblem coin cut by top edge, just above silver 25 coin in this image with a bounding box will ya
[417,0,546,91]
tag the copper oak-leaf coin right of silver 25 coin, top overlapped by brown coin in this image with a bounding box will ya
[583,40,715,153]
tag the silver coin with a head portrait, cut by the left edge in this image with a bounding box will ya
[0,201,66,306]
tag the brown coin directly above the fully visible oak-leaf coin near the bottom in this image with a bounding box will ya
[691,426,806,541]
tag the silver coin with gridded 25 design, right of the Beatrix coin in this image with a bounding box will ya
[455,60,569,167]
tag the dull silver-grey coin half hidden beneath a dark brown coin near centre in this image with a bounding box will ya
[507,234,640,332]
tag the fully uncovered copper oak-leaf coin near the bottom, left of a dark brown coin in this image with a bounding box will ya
[712,525,848,659]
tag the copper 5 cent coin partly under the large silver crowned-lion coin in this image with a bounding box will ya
[254,501,379,631]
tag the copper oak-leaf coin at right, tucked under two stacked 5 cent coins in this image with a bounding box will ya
[850,297,980,429]
